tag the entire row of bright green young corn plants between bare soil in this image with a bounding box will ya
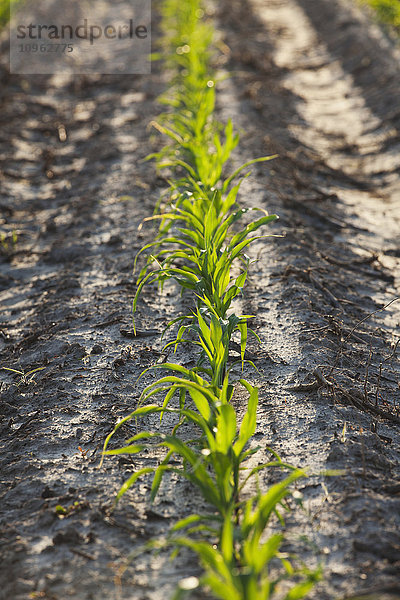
[104,0,319,600]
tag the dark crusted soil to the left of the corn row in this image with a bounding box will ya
[0,63,205,600]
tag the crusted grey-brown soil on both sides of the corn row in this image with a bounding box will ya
[0,0,400,600]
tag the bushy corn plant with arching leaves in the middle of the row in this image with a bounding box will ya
[133,193,277,318]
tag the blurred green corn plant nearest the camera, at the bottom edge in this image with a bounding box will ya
[170,469,321,600]
